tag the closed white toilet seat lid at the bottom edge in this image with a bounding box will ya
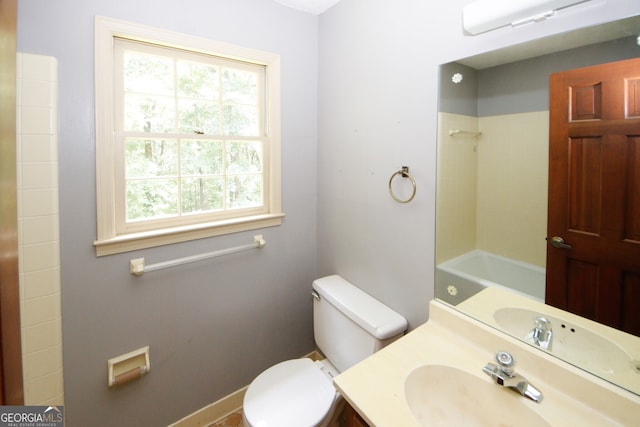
[243,358,337,427]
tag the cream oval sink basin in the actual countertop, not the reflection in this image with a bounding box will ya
[405,365,550,427]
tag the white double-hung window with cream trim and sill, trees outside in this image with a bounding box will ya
[94,17,283,256]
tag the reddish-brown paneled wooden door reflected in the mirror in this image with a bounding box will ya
[546,58,640,335]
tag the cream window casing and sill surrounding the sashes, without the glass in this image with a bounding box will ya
[94,16,284,256]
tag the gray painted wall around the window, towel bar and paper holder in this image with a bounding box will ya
[18,0,318,426]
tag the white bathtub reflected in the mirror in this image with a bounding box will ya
[436,249,546,305]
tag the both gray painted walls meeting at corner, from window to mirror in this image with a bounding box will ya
[18,0,640,426]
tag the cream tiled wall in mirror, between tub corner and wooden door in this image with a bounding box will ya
[476,111,549,266]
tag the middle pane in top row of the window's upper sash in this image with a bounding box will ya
[177,61,219,101]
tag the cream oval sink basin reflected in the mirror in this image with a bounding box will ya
[493,307,637,377]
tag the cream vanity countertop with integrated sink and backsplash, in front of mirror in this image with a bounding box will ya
[334,301,640,427]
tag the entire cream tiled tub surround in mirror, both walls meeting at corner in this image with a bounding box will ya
[436,111,549,266]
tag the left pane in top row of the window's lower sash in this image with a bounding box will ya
[125,138,178,178]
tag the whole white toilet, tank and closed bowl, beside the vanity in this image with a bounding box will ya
[243,275,407,427]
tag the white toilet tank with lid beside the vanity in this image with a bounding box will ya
[313,275,407,372]
